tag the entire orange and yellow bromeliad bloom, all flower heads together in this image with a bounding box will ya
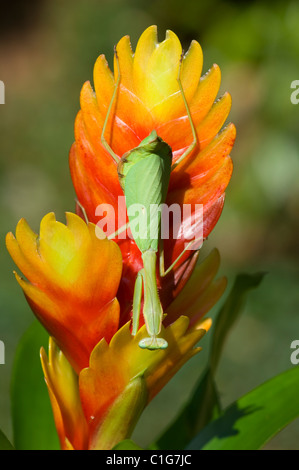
[6,26,235,449]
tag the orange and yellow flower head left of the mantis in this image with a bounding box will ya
[6,213,122,372]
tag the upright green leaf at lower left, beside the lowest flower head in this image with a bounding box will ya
[11,321,59,450]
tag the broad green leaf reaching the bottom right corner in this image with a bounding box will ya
[187,367,299,450]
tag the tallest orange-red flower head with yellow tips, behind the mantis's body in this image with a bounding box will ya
[70,26,236,324]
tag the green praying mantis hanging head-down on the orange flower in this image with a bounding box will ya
[101,48,204,350]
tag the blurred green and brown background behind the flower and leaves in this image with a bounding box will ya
[0,0,299,449]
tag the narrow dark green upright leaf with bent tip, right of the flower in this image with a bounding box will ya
[155,273,264,450]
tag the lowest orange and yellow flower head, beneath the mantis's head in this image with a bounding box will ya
[41,316,211,450]
